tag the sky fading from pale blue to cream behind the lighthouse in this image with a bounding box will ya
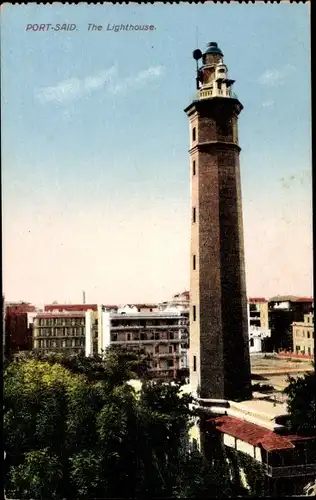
[1,4,312,303]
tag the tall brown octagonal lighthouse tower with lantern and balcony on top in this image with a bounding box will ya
[185,42,251,401]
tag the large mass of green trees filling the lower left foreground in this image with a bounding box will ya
[4,350,233,500]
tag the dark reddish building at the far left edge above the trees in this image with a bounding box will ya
[4,302,36,357]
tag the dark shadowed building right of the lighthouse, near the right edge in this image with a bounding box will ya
[266,295,314,351]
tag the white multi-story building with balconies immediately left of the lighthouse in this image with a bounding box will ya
[92,306,188,380]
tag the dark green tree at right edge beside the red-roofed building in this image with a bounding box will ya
[284,372,316,436]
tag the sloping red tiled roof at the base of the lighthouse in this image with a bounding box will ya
[209,415,294,451]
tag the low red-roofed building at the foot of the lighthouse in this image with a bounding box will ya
[190,397,316,497]
